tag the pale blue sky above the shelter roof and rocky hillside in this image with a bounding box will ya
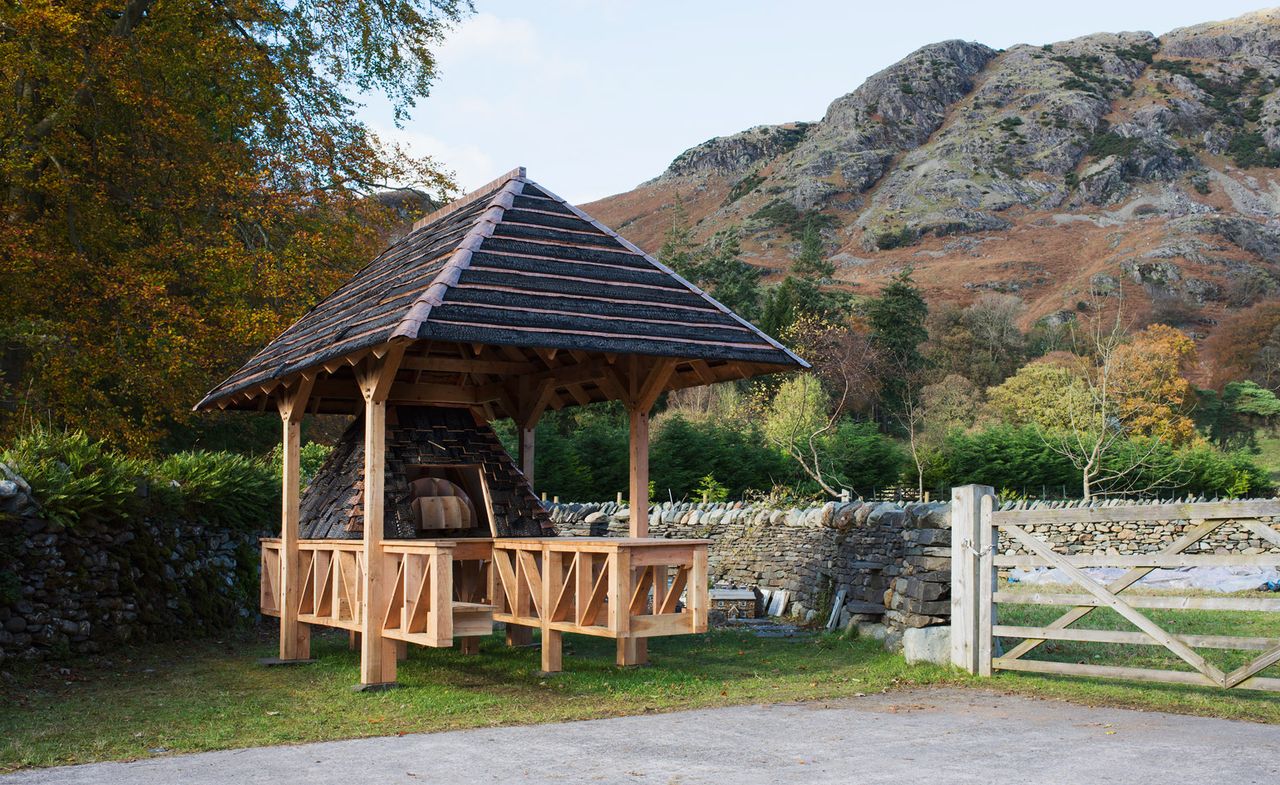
[357,0,1265,204]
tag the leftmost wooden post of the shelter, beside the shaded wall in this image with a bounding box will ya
[276,378,311,662]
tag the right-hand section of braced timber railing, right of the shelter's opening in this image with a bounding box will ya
[493,537,709,671]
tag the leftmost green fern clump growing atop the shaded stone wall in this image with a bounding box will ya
[0,429,143,526]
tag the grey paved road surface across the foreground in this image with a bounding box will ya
[0,690,1280,785]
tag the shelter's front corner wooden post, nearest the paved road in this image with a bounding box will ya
[357,343,404,689]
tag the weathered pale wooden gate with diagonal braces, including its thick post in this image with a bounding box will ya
[951,485,1280,690]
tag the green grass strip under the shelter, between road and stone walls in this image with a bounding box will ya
[0,631,963,771]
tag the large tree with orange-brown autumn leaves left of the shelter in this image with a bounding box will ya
[0,0,468,452]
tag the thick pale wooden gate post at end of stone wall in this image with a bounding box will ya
[951,485,995,674]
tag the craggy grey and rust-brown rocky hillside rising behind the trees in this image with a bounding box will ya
[585,9,1280,350]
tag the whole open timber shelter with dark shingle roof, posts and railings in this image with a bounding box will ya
[196,169,806,686]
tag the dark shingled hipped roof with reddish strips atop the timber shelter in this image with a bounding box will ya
[196,168,808,409]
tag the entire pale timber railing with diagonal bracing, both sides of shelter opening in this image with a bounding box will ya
[260,537,709,671]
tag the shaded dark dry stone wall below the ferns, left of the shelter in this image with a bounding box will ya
[0,464,265,665]
